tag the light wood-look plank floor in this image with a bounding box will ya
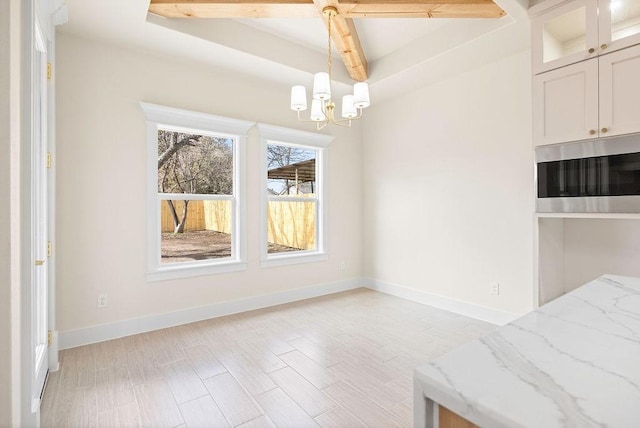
[41,289,495,428]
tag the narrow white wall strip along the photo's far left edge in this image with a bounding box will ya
[0,0,23,426]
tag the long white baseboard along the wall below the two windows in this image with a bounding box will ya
[58,278,365,349]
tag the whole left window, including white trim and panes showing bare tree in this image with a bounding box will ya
[141,103,253,281]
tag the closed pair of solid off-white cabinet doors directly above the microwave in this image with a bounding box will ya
[533,45,640,146]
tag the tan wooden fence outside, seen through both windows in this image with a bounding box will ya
[160,195,316,250]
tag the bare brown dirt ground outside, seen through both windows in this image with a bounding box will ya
[162,230,297,263]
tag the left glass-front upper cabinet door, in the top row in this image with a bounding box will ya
[531,0,596,74]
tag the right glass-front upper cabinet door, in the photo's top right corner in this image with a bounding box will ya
[598,0,640,54]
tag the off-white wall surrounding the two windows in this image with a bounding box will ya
[55,34,362,338]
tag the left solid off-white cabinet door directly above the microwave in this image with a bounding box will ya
[533,58,598,146]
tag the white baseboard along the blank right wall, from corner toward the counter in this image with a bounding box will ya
[362,279,521,325]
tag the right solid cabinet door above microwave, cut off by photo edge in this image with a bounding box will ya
[599,45,640,137]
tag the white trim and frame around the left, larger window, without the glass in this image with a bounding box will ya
[140,102,255,282]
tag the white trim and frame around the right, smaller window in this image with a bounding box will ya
[257,123,335,268]
